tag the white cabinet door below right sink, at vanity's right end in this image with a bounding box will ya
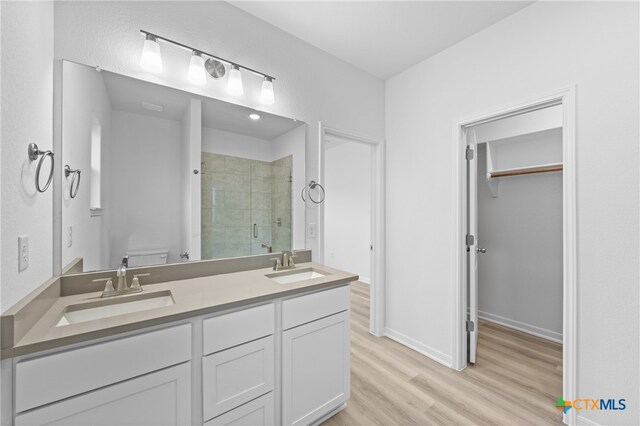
[282,311,350,425]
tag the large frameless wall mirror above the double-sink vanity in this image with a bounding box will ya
[60,61,306,273]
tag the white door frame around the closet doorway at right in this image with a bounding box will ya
[451,86,578,425]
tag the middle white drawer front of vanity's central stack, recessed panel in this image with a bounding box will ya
[202,336,275,420]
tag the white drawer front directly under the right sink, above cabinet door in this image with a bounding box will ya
[282,285,350,330]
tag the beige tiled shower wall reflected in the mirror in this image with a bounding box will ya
[201,152,293,259]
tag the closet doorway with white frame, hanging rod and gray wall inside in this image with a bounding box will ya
[453,89,577,424]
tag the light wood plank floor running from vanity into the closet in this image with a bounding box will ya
[324,283,562,426]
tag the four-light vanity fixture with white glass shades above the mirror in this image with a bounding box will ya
[140,30,275,105]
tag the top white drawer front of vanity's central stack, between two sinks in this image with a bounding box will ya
[202,303,275,355]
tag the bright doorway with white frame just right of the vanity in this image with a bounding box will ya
[318,123,384,336]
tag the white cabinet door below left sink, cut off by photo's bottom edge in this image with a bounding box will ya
[15,362,191,426]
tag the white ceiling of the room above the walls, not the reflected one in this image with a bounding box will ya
[229,1,533,79]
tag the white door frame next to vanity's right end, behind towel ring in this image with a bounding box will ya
[316,122,385,336]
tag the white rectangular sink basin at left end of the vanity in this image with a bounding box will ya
[56,290,175,327]
